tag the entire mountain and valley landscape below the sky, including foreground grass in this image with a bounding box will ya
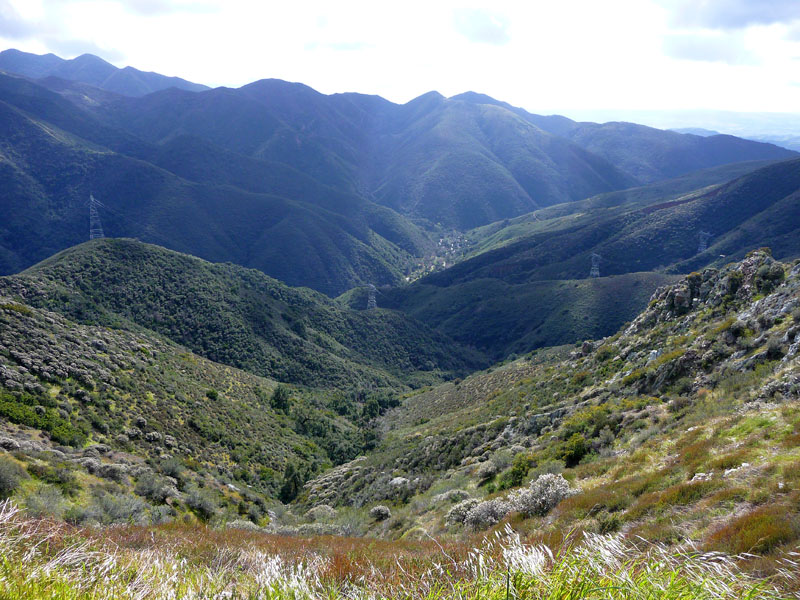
[0,50,800,600]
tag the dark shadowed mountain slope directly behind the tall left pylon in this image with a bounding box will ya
[0,71,430,294]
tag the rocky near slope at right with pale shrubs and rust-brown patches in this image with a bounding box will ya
[302,251,800,570]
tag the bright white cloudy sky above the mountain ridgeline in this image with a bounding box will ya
[0,0,800,114]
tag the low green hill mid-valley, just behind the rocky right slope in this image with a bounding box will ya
[381,273,675,360]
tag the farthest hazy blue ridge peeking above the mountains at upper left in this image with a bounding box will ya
[0,48,208,96]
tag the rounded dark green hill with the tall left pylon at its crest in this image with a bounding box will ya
[0,239,483,389]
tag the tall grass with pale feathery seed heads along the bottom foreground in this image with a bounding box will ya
[0,502,798,600]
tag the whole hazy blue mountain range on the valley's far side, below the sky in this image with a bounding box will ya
[0,50,798,295]
